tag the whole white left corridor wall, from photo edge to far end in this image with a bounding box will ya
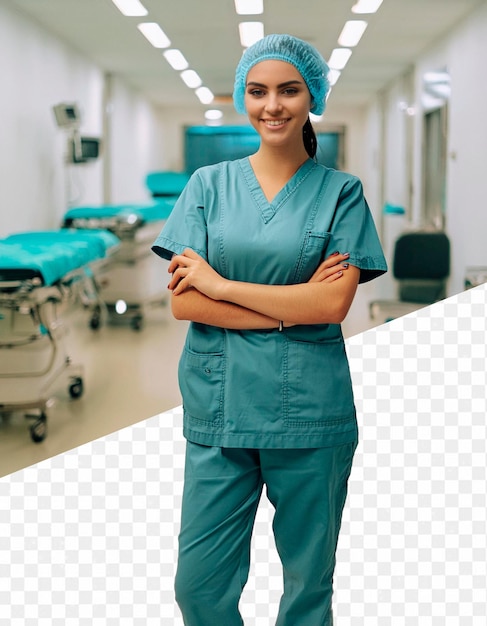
[0,4,170,237]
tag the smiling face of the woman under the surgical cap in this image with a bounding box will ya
[245,60,311,147]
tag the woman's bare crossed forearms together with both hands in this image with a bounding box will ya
[168,249,360,330]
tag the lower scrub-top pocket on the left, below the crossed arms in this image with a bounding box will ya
[178,349,224,426]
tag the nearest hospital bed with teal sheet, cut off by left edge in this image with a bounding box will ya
[0,229,119,442]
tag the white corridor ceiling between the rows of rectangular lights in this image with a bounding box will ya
[4,0,485,114]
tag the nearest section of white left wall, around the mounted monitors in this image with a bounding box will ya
[0,6,102,236]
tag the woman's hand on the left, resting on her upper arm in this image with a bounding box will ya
[168,248,225,300]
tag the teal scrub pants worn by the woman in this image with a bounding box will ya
[175,442,356,626]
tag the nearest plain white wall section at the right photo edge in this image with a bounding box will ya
[440,4,487,293]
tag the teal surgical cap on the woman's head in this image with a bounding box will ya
[233,35,330,115]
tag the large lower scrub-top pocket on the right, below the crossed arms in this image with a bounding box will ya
[283,339,355,428]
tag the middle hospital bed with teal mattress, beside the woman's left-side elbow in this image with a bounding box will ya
[63,200,176,330]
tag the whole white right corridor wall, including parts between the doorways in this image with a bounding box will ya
[368,4,487,297]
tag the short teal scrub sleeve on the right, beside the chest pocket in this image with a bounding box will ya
[328,177,387,283]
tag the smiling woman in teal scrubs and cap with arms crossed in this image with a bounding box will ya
[153,35,386,626]
